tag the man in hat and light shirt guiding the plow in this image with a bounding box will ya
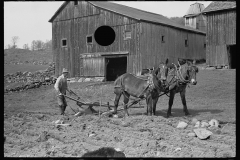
[54,68,72,115]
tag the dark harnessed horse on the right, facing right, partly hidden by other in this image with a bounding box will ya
[165,61,198,117]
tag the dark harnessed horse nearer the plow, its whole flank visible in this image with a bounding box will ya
[113,59,168,116]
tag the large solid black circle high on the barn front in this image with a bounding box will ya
[94,26,116,46]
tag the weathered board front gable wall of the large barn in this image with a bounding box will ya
[53,1,139,77]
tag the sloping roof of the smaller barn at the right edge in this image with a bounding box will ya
[203,1,236,13]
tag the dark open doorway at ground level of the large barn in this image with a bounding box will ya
[105,57,127,81]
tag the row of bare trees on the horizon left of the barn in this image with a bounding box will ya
[5,36,52,51]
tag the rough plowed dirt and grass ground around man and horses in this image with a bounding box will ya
[4,70,236,157]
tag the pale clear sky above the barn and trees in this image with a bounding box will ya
[4,1,211,48]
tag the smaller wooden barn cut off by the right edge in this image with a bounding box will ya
[203,1,236,68]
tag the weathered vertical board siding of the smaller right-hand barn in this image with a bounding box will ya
[206,10,236,66]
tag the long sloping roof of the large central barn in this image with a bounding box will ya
[49,1,206,34]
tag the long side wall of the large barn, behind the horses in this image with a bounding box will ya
[140,22,206,68]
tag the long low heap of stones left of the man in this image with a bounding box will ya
[4,63,56,93]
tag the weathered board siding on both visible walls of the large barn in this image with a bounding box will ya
[52,1,206,77]
